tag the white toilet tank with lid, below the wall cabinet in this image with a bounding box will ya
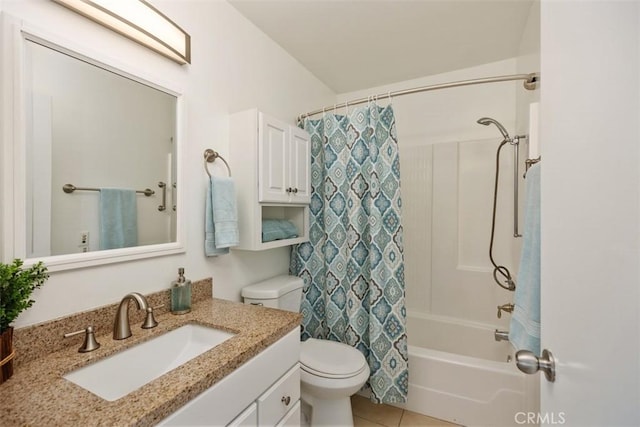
[242,274,304,312]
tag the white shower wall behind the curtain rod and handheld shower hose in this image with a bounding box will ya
[338,58,534,327]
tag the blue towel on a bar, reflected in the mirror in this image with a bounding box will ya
[99,188,138,249]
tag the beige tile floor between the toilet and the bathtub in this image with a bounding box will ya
[351,394,458,427]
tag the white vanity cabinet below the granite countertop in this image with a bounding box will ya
[158,327,300,427]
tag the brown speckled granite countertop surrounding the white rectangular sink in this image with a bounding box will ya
[0,298,301,427]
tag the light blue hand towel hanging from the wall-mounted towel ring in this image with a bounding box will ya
[204,177,240,256]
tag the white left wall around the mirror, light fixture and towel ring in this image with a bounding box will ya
[0,0,335,327]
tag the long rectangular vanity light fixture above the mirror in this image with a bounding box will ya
[53,0,191,64]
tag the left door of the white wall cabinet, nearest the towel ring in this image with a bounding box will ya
[258,113,290,202]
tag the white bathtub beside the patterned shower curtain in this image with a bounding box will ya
[398,312,539,426]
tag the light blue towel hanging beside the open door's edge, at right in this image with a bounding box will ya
[509,164,540,356]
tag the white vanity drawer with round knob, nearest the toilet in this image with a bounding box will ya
[258,363,300,426]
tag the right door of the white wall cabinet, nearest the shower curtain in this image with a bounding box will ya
[289,127,311,203]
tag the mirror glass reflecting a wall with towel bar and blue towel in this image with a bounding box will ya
[25,40,177,258]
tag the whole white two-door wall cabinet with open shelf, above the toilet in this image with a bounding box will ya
[229,109,311,250]
